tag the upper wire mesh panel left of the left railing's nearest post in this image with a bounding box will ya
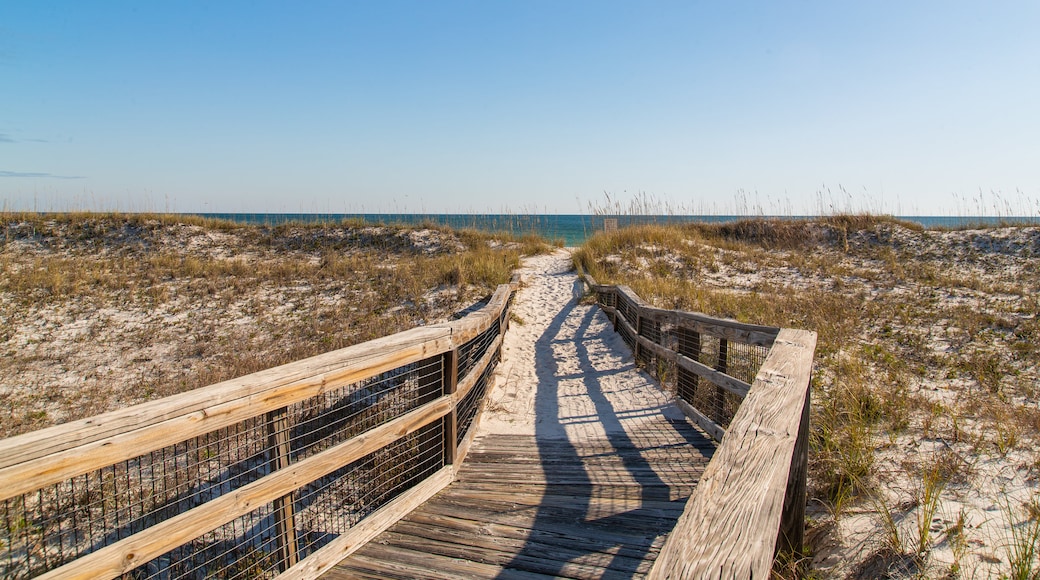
[0,418,269,578]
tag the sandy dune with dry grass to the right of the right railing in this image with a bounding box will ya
[575,215,1040,577]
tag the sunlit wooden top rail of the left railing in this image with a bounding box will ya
[0,276,519,500]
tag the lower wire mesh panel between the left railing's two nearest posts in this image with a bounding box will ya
[293,421,445,558]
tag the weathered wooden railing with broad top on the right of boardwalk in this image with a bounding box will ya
[582,274,816,579]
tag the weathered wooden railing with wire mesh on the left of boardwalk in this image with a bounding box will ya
[0,279,518,579]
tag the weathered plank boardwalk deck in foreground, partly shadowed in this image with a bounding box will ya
[323,416,714,580]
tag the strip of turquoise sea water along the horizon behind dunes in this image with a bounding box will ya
[191,213,1040,245]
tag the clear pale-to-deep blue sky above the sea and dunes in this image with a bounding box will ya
[0,0,1040,215]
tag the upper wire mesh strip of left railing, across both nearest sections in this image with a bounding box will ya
[0,357,444,578]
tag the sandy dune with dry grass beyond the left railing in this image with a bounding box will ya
[0,213,548,437]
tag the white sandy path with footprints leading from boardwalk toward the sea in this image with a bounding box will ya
[479,251,684,442]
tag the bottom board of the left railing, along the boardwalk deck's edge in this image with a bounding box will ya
[279,466,452,580]
